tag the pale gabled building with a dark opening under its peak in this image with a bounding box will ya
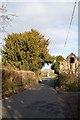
[60,53,80,75]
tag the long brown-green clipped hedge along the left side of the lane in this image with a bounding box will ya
[2,69,37,98]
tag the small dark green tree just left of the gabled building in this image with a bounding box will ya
[51,55,64,73]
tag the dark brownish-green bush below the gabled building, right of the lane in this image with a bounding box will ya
[59,73,80,91]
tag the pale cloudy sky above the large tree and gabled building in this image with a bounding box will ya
[2,0,78,60]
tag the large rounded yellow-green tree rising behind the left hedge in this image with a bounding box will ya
[2,29,51,71]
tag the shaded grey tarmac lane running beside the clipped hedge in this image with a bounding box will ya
[2,78,72,119]
